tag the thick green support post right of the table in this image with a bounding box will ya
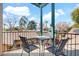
[51,3,55,46]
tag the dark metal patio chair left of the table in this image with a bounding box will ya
[19,36,38,56]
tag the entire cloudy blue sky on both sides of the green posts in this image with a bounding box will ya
[3,3,79,26]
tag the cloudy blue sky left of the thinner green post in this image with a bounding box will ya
[3,3,39,25]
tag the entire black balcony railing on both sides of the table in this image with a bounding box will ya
[2,31,79,56]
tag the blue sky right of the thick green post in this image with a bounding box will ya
[55,3,79,25]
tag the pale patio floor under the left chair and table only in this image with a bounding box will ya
[3,49,54,56]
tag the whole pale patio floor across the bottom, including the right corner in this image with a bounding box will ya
[2,45,79,56]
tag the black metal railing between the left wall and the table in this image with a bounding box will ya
[2,31,37,52]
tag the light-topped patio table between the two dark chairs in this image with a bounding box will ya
[27,35,53,56]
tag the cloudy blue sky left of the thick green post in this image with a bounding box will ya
[3,3,50,26]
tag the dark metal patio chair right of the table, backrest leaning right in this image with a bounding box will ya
[47,38,69,56]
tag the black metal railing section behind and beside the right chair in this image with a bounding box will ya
[57,33,79,56]
